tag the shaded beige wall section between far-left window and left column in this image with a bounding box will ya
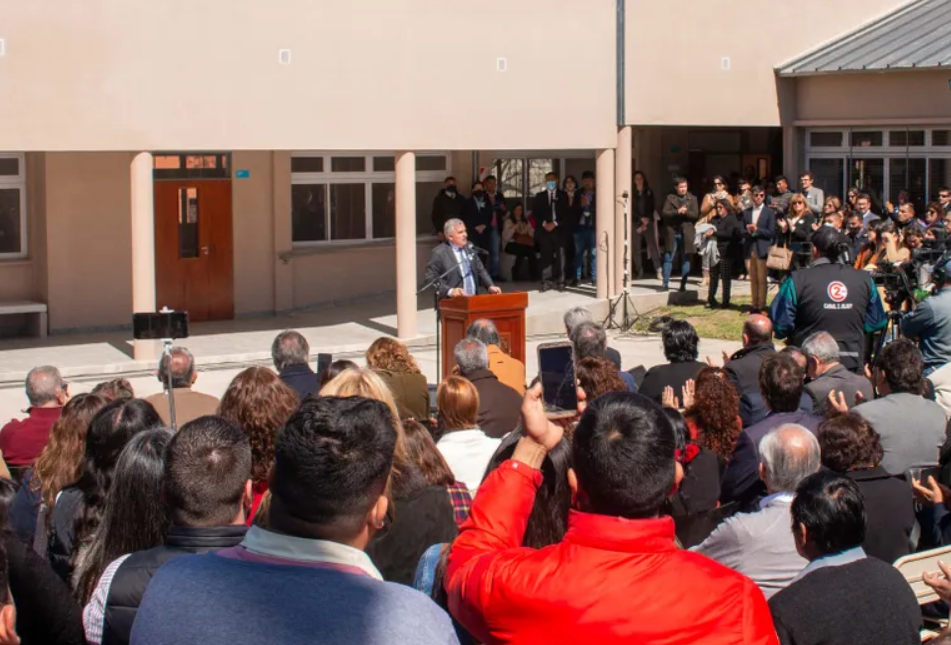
[45,152,133,331]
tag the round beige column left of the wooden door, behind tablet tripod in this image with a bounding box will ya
[129,152,158,360]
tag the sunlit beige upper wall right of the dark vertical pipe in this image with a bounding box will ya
[625,0,908,126]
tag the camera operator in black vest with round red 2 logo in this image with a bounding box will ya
[770,226,888,372]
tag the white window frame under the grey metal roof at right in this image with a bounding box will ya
[803,125,951,204]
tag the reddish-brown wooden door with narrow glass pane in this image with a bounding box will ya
[154,179,234,322]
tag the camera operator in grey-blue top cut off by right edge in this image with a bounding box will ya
[901,254,951,376]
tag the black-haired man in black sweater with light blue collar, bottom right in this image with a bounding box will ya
[769,471,921,645]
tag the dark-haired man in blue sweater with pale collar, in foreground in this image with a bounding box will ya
[130,397,457,645]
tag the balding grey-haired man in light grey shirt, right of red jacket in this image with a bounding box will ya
[692,424,820,599]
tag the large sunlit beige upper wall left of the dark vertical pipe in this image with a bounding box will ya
[0,0,616,151]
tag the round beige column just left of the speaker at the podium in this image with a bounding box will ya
[396,152,417,338]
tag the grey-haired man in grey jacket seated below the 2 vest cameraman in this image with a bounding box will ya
[802,331,875,415]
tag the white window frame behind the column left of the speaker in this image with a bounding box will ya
[291,150,452,249]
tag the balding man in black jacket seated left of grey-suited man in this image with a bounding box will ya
[723,314,776,428]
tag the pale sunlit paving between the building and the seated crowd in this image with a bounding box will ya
[0,280,745,421]
